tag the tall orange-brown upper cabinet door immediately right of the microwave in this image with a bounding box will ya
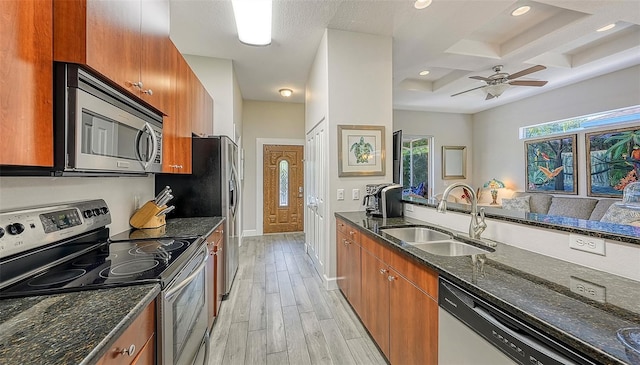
[162,45,191,174]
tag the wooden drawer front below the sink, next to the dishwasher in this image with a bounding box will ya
[384,250,438,300]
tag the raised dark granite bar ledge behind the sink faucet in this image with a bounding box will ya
[402,196,640,245]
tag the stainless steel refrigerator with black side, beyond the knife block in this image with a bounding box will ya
[155,136,240,298]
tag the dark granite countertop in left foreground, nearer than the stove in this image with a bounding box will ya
[0,284,160,365]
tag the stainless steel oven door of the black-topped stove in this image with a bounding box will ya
[159,245,212,365]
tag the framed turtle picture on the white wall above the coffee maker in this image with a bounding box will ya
[338,125,385,176]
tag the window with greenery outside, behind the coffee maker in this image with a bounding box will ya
[402,136,433,198]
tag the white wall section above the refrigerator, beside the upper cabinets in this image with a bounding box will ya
[184,55,242,141]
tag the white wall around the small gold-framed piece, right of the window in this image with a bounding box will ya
[393,110,474,195]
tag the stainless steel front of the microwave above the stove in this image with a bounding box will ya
[71,89,162,173]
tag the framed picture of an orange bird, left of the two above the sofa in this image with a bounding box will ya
[524,134,578,194]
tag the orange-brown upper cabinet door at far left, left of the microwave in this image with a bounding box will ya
[0,0,53,167]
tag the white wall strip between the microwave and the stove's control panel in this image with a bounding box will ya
[0,175,154,234]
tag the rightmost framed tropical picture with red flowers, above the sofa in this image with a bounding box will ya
[585,126,640,198]
